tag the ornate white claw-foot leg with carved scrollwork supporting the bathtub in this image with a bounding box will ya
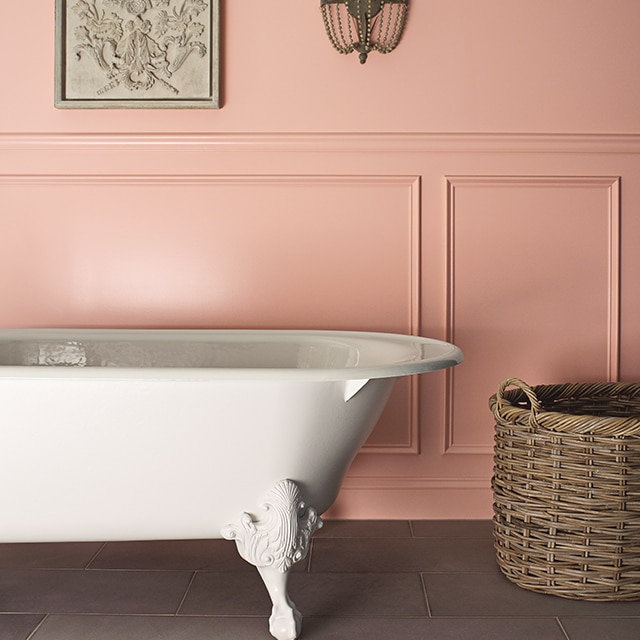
[221,480,322,640]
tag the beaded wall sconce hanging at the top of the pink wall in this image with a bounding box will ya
[320,0,409,64]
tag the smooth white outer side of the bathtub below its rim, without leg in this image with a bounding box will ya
[0,376,393,542]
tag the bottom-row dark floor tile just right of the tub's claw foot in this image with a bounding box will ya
[300,617,564,640]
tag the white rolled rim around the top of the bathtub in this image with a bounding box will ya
[0,328,464,381]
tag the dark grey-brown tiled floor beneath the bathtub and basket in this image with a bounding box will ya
[0,521,640,640]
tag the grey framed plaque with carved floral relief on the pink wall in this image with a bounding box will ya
[55,0,219,109]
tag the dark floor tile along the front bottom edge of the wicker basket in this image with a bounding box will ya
[424,573,640,616]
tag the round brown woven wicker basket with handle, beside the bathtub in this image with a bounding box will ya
[489,378,640,600]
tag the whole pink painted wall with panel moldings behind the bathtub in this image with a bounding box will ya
[0,0,640,518]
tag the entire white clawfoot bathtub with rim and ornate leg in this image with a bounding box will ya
[0,329,462,640]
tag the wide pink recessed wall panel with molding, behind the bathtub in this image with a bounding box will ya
[0,174,420,453]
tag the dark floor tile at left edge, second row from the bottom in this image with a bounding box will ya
[0,569,192,613]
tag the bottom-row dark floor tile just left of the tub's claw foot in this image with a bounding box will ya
[31,615,273,640]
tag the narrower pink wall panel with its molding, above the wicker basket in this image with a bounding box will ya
[444,175,620,454]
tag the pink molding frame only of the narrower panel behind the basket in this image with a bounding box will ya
[444,175,621,455]
